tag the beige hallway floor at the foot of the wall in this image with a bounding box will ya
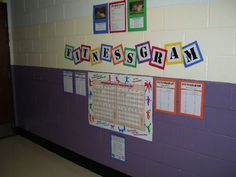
[0,136,99,177]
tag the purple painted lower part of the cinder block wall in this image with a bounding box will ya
[12,66,236,177]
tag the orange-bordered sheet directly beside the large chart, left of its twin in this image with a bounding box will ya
[155,78,177,114]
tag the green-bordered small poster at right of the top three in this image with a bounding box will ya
[128,0,147,31]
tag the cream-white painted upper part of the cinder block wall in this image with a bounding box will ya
[7,0,236,83]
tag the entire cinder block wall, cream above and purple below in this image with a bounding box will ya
[7,0,236,177]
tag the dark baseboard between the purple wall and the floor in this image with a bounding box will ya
[16,127,131,177]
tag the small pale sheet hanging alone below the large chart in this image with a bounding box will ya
[111,135,125,162]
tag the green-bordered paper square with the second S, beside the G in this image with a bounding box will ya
[123,47,137,68]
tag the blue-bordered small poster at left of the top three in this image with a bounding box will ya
[93,4,108,34]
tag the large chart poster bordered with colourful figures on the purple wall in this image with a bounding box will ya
[88,72,153,141]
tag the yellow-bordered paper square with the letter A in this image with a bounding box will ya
[165,42,183,65]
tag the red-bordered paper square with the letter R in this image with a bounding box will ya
[149,46,167,70]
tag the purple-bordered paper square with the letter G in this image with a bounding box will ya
[135,41,152,63]
